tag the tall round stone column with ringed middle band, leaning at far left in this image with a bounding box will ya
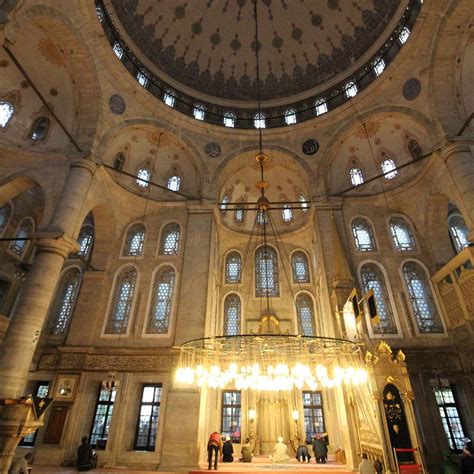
[0,158,95,399]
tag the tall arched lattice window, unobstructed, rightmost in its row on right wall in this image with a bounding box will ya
[403,261,443,333]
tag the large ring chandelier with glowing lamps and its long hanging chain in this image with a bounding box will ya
[176,0,367,391]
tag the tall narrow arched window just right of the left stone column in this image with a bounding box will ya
[49,267,82,336]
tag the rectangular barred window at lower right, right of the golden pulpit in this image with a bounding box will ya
[433,387,466,451]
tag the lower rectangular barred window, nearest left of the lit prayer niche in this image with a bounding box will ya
[134,384,163,451]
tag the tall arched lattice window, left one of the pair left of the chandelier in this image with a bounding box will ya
[105,266,137,334]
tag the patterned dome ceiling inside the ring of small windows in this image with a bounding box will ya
[107,0,401,102]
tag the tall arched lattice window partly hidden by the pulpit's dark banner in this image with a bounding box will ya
[360,263,397,334]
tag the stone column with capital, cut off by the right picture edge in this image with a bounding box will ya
[441,142,474,237]
